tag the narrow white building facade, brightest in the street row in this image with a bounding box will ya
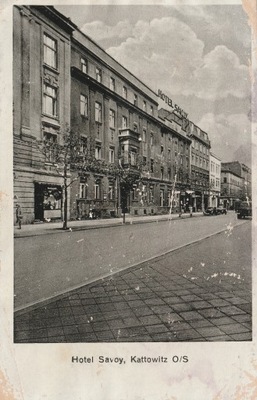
[209,152,221,207]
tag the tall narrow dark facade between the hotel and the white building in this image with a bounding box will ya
[188,121,211,211]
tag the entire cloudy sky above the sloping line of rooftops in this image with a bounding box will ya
[56,5,251,166]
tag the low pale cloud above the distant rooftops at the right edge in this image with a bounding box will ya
[197,113,251,166]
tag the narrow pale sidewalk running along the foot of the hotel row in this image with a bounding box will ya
[14,212,203,238]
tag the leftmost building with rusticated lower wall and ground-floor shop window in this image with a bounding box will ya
[13,6,75,223]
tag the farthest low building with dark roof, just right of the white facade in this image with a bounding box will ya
[220,167,243,209]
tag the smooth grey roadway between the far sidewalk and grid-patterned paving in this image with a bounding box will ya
[14,213,244,310]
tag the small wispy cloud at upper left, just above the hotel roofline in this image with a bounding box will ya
[81,20,133,41]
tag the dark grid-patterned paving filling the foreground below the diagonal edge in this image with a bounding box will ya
[14,218,251,343]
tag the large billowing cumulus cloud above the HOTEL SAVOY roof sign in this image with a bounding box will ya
[104,17,249,100]
